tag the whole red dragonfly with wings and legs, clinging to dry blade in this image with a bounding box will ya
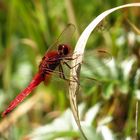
[2,24,110,117]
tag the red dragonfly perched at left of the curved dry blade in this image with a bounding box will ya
[2,24,75,117]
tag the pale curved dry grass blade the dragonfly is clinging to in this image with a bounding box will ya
[69,3,140,139]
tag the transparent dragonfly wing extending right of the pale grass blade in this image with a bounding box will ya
[81,50,112,78]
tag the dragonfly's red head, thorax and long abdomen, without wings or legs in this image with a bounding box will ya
[2,44,69,117]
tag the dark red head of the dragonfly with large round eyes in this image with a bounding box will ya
[58,44,70,56]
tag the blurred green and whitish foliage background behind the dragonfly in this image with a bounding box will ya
[0,0,140,140]
